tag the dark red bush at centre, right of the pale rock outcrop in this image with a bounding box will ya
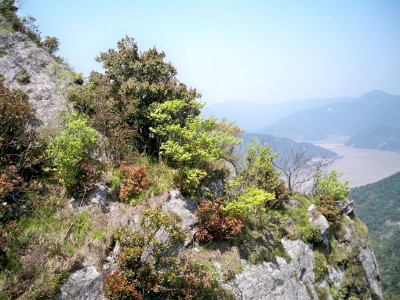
[194,200,243,242]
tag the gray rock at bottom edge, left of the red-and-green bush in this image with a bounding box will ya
[53,267,106,300]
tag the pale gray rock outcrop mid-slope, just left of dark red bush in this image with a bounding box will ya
[162,190,198,246]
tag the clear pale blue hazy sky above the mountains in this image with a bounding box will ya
[20,0,400,104]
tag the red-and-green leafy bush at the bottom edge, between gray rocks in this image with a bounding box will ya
[104,209,222,299]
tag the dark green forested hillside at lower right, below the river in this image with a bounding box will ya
[350,173,400,299]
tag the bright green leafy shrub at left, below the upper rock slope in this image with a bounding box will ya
[47,113,98,193]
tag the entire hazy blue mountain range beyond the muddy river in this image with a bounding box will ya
[203,91,400,152]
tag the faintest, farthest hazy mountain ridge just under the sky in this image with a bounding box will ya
[202,98,353,133]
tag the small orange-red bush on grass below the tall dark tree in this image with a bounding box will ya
[119,164,150,202]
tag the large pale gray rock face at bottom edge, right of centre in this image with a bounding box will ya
[227,239,317,299]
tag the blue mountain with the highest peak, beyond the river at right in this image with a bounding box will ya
[262,91,400,141]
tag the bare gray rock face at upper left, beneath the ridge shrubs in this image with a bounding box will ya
[0,32,72,128]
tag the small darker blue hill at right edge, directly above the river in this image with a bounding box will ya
[345,125,400,152]
